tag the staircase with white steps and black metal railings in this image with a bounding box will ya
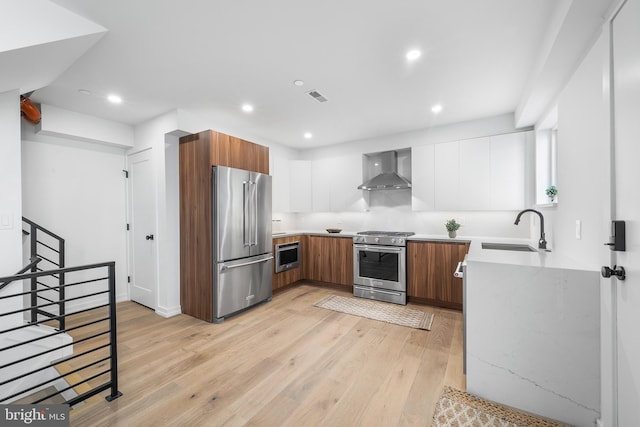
[0,218,121,406]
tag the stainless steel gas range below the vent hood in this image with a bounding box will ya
[353,231,415,305]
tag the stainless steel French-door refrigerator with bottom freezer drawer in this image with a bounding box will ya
[212,166,273,323]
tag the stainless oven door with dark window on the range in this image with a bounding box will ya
[353,245,407,292]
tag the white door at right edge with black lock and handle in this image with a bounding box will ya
[612,0,640,427]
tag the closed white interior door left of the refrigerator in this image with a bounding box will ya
[129,150,158,310]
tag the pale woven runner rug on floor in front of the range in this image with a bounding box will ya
[314,295,433,331]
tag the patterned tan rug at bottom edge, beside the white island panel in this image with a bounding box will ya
[431,386,567,427]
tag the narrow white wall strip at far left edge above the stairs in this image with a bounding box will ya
[0,90,24,325]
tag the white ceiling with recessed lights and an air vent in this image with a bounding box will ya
[27,0,610,148]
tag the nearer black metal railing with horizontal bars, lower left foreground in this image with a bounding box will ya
[0,261,122,406]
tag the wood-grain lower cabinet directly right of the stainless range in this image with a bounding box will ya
[407,242,469,309]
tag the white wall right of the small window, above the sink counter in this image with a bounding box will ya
[544,30,610,268]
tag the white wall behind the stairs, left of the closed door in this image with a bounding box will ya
[22,124,128,311]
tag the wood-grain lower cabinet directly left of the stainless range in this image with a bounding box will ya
[303,236,353,286]
